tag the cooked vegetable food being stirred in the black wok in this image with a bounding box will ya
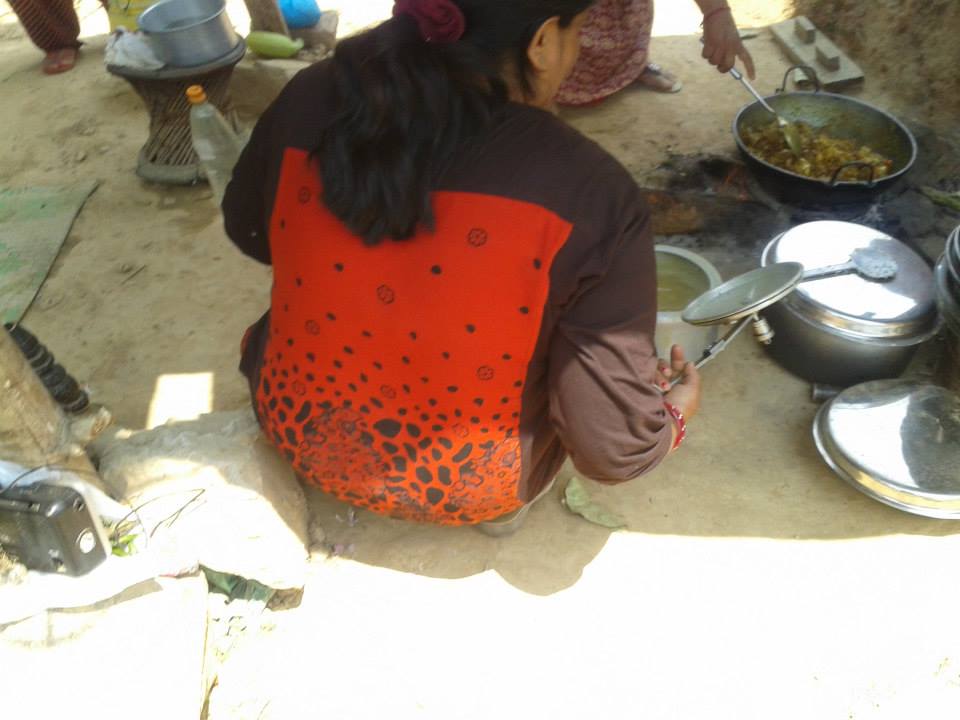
[742,122,893,182]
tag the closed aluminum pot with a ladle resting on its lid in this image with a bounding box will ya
[762,221,941,387]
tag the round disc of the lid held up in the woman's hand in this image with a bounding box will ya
[682,262,803,325]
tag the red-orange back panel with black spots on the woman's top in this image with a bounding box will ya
[255,149,571,525]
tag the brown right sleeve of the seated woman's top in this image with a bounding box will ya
[549,208,671,482]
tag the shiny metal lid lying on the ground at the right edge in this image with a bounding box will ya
[813,380,960,519]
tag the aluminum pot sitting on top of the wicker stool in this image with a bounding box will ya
[137,0,240,67]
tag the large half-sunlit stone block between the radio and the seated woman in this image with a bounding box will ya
[94,410,308,589]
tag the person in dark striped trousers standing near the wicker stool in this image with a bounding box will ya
[9,0,107,75]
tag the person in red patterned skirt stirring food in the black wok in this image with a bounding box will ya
[557,0,754,106]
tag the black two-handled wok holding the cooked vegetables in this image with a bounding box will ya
[733,65,917,209]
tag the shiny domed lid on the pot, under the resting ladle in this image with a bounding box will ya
[762,220,937,338]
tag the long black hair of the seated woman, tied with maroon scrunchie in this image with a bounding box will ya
[313,0,592,245]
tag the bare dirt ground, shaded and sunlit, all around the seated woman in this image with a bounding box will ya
[0,0,960,720]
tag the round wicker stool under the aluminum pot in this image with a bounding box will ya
[107,40,247,185]
